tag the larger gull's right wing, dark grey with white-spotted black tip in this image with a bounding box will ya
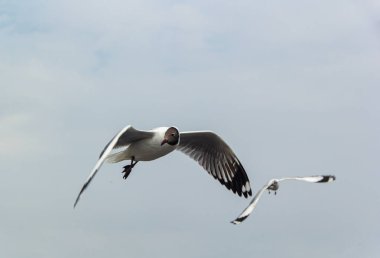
[177,132,252,198]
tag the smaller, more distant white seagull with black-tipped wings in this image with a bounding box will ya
[231,175,335,225]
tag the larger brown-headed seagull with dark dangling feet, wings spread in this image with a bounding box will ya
[74,125,252,208]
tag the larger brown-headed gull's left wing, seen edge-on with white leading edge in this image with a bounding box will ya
[74,125,153,208]
